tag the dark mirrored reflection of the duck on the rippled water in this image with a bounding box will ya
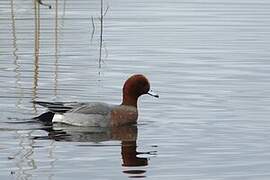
[34,124,151,177]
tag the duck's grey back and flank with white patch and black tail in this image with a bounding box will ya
[33,101,115,127]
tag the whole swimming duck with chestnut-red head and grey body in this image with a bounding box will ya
[32,74,159,127]
